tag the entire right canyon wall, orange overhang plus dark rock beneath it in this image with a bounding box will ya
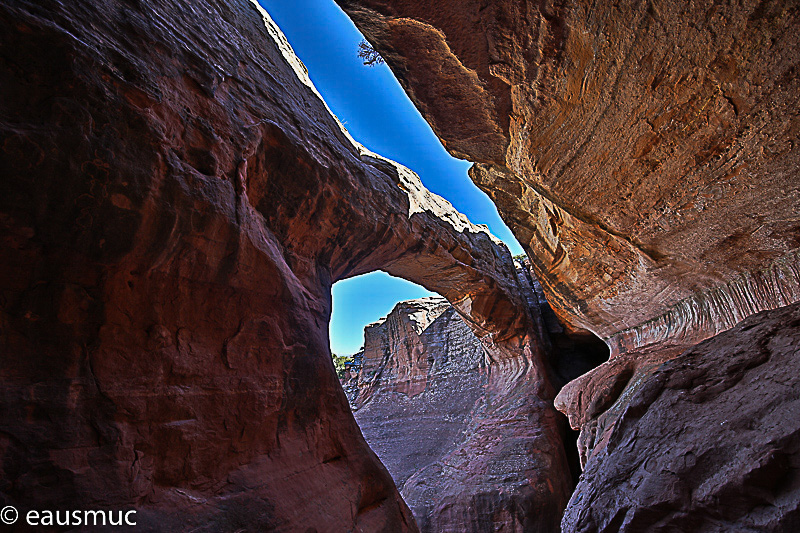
[337,0,800,532]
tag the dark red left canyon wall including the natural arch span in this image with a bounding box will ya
[0,0,567,531]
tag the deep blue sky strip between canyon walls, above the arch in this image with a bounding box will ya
[259,0,523,255]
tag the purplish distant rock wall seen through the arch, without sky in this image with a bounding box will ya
[352,298,494,531]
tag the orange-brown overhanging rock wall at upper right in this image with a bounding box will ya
[338,0,800,352]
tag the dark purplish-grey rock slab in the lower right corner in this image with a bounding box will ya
[562,304,800,532]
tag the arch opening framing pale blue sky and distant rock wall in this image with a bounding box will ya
[330,271,462,494]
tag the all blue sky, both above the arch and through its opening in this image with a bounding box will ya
[259,0,522,355]
